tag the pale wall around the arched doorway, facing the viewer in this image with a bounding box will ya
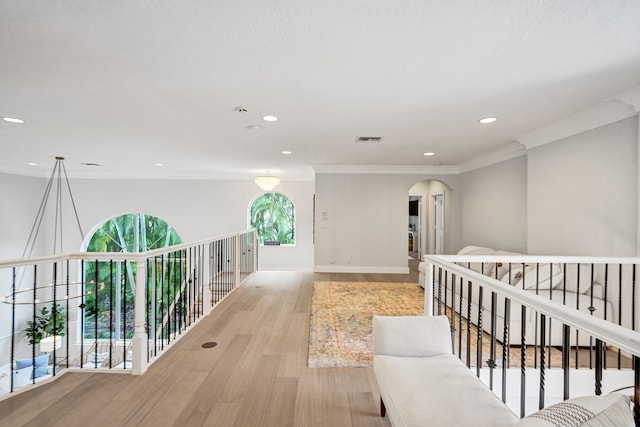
[315,173,457,273]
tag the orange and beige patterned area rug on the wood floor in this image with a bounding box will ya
[309,282,424,368]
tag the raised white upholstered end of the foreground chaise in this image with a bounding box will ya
[373,316,452,357]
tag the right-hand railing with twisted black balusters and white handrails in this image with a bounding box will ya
[425,256,640,416]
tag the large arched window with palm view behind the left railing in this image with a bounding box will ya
[81,213,182,340]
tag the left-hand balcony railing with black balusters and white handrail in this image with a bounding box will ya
[0,231,257,393]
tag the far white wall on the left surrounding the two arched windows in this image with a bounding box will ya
[0,174,314,269]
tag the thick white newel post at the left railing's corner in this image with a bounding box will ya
[131,259,147,375]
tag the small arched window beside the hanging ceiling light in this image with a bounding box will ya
[249,193,296,245]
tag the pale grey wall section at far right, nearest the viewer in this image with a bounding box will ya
[527,116,638,256]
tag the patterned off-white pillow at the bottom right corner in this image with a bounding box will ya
[517,393,635,427]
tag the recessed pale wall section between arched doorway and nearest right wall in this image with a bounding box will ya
[460,156,527,252]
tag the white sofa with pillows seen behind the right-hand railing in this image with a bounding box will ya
[419,246,615,346]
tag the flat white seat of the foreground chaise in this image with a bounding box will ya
[373,354,518,427]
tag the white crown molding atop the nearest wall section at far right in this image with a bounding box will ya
[517,98,637,150]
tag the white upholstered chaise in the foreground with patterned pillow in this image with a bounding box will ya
[373,316,634,427]
